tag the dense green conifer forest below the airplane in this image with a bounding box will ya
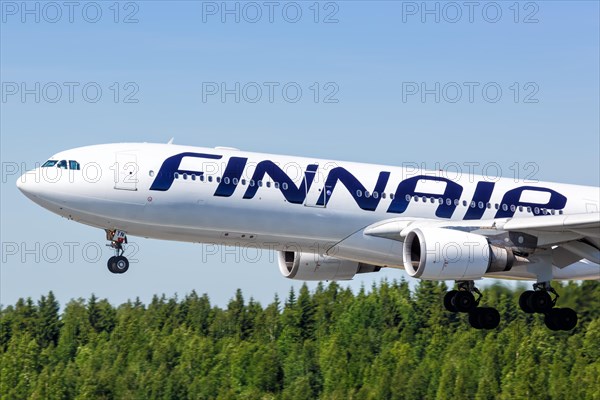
[0,280,600,400]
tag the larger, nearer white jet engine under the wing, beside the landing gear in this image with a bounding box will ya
[403,227,515,280]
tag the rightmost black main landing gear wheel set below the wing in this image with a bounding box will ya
[519,282,577,331]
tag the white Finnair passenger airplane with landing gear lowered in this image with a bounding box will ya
[17,141,600,331]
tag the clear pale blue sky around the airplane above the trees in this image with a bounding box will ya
[0,1,600,305]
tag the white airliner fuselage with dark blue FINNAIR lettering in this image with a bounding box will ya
[18,143,600,280]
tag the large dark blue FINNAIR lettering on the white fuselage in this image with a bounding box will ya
[150,152,567,220]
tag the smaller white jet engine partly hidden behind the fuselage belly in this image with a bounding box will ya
[279,251,381,281]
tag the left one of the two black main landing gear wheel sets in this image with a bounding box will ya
[444,281,500,329]
